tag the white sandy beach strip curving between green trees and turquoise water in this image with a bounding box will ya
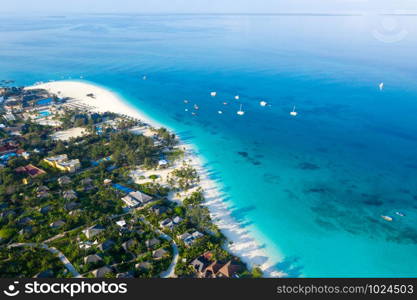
[27,80,286,277]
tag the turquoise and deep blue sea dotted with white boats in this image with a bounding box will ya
[0,15,417,277]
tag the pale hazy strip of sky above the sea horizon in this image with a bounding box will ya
[0,0,417,14]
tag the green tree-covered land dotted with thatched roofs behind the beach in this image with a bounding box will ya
[0,89,250,278]
